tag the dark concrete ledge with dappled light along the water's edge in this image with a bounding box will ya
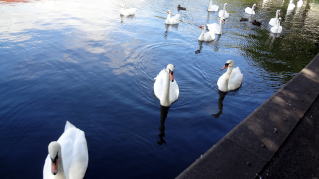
[177,54,319,179]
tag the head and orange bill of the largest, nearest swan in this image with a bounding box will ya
[48,141,61,175]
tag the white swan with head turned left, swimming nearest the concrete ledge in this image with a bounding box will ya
[217,60,243,92]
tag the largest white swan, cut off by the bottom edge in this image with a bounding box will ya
[43,121,89,179]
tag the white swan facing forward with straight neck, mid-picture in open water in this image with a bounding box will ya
[154,64,179,107]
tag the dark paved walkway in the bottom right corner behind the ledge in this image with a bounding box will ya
[261,96,319,179]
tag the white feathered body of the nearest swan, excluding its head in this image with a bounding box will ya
[58,122,88,179]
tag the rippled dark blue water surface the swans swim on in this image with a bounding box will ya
[0,0,319,179]
